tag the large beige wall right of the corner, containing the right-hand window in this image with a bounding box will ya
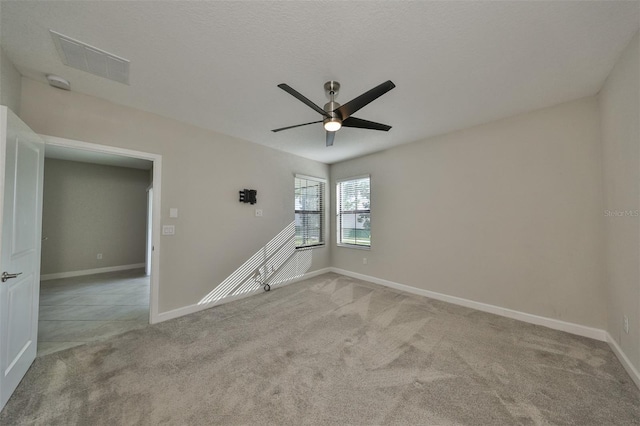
[331,98,605,328]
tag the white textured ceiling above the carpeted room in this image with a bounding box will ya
[0,1,640,163]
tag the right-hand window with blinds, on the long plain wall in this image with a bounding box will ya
[337,176,371,247]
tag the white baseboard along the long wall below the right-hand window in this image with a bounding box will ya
[330,268,607,342]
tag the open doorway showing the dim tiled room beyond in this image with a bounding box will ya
[38,151,153,356]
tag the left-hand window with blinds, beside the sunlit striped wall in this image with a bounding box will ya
[294,175,326,248]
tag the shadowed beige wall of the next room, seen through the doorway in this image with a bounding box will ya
[41,158,149,274]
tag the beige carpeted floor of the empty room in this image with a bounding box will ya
[0,274,640,425]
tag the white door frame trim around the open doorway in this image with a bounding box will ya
[39,135,162,324]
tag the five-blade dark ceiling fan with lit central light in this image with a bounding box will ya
[272,80,396,146]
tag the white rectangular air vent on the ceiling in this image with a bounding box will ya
[49,30,129,84]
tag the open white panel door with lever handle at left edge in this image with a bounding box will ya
[0,106,44,409]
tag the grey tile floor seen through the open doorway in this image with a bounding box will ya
[38,269,149,356]
